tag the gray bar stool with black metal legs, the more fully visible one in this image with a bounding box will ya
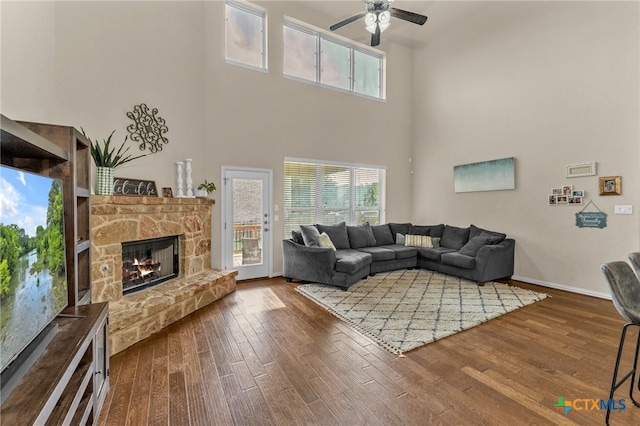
[600,262,640,425]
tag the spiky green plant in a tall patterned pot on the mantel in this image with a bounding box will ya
[80,128,147,195]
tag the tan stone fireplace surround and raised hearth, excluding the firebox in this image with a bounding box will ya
[91,195,237,355]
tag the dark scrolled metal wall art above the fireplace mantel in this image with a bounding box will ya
[127,104,169,154]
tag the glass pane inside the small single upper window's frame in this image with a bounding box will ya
[226,3,266,68]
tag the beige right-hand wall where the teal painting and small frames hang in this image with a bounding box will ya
[412,2,640,294]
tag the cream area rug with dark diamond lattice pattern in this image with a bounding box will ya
[296,269,547,355]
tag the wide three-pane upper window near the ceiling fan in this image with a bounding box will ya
[284,18,384,99]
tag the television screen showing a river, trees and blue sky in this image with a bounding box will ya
[0,166,67,370]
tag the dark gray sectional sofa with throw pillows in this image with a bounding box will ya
[282,222,515,289]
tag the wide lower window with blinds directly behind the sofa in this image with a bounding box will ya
[284,159,385,238]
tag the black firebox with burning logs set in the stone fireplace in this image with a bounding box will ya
[122,235,180,294]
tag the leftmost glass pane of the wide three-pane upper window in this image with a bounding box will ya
[284,26,317,81]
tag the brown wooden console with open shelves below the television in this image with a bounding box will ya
[0,303,109,426]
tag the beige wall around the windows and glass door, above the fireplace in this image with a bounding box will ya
[2,1,412,273]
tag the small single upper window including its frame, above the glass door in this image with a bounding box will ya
[225,0,267,71]
